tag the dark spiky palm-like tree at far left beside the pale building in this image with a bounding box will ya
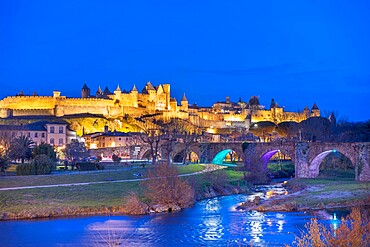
[9,136,35,163]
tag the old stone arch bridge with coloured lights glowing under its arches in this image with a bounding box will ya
[91,142,370,181]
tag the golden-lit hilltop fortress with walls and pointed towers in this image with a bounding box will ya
[0,82,320,133]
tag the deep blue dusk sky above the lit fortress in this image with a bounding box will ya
[0,0,370,121]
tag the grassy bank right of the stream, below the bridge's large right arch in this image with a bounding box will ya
[251,170,370,211]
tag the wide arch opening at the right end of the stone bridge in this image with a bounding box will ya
[309,149,355,179]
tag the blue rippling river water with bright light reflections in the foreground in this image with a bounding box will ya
[0,195,342,247]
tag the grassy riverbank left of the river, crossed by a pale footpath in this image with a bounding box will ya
[0,165,249,219]
